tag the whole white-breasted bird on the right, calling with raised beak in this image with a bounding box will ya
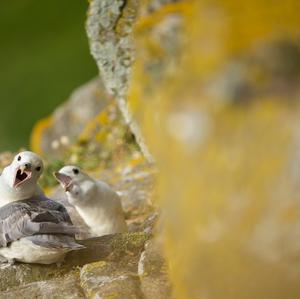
[54,165,127,236]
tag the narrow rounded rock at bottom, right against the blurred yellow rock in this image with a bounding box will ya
[138,240,171,299]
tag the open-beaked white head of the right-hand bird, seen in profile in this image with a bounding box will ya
[54,165,95,205]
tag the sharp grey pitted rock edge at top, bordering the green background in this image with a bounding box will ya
[86,0,139,96]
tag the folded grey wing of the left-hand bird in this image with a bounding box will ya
[0,203,79,247]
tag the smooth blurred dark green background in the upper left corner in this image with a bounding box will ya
[0,0,97,151]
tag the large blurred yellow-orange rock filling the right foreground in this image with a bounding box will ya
[128,0,300,299]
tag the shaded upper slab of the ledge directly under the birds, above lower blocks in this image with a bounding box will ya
[0,233,149,298]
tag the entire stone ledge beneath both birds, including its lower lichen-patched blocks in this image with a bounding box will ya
[0,233,149,298]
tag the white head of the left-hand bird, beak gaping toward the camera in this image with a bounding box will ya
[1,151,44,199]
